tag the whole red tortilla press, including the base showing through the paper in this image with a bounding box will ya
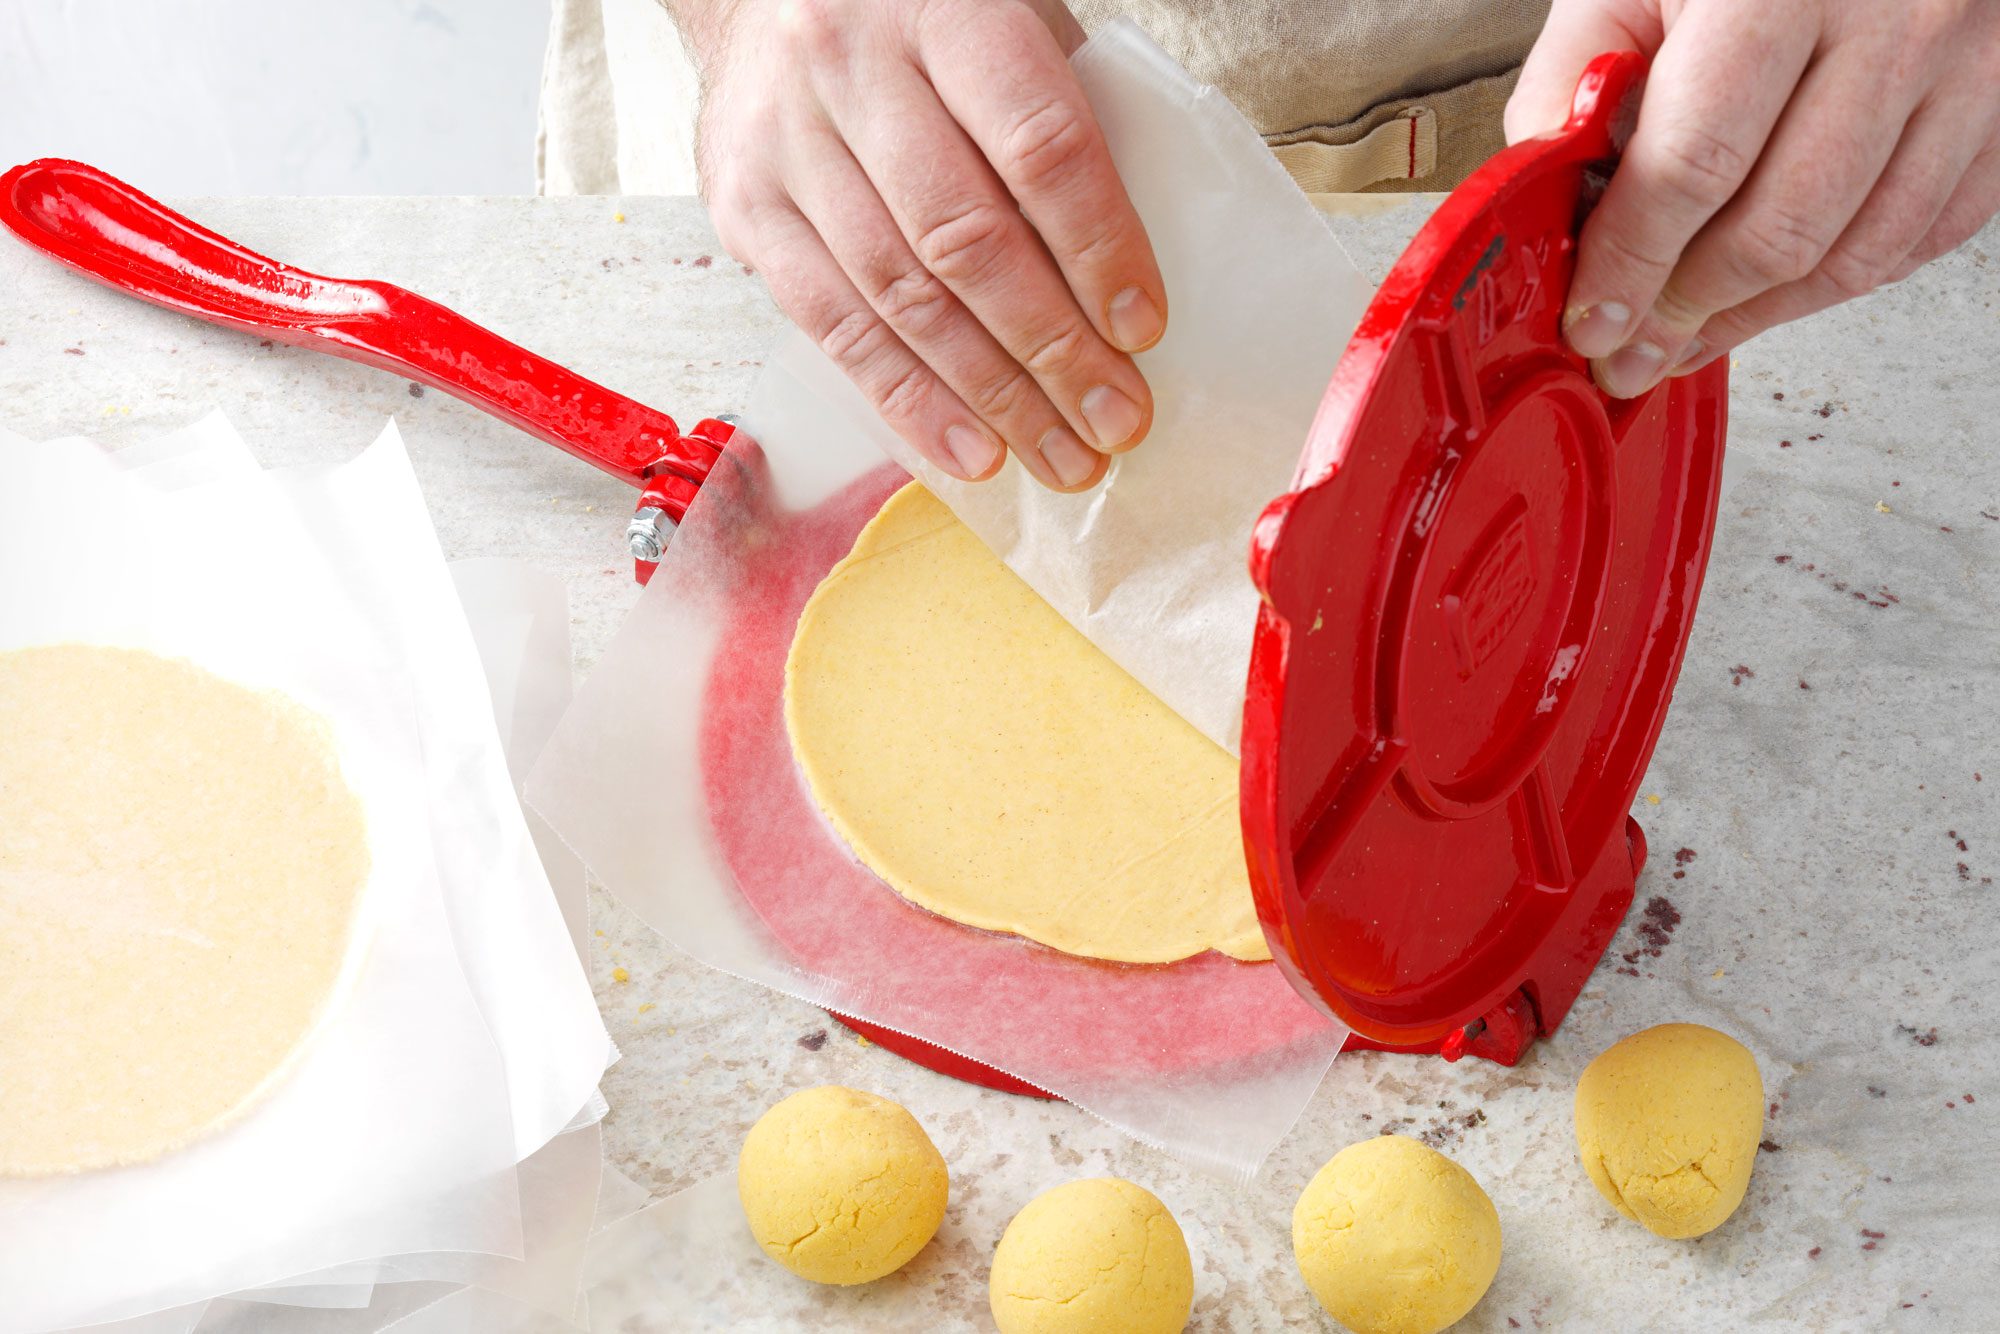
[0,56,1728,1082]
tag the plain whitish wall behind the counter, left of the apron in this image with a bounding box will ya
[0,0,550,196]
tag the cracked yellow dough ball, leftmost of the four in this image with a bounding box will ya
[736,1084,948,1284]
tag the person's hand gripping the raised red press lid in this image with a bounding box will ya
[1506,0,2000,398]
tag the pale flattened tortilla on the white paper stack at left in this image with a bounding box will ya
[0,644,370,1176]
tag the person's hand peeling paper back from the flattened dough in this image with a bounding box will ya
[674,0,1166,490]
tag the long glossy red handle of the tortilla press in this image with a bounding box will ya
[0,158,718,490]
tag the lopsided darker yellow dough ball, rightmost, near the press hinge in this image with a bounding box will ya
[1576,1024,1764,1238]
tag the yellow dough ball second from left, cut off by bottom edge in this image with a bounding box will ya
[988,1176,1194,1334]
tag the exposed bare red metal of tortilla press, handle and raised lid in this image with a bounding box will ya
[0,54,1728,1092]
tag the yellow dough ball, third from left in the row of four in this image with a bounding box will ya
[1292,1134,1500,1334]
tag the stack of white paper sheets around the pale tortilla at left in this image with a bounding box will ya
[0,418,612,1330]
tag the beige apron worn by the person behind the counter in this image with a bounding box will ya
[538,0,1548,194]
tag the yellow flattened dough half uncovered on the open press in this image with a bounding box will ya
[784,482,1270,964]
